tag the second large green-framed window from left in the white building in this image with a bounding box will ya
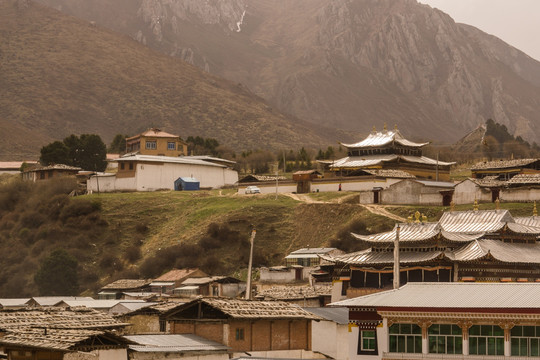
[428,324,463,354]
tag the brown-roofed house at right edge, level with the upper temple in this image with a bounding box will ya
[471,159,540,180]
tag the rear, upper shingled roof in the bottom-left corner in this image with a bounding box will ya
[0,307,126,330]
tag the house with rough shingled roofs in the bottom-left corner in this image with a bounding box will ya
[0,308,129,360]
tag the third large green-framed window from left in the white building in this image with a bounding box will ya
[469,325,504,355]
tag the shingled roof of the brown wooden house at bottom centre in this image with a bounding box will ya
[167,297,319,320]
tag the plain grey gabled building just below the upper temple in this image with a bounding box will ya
[360,179,455,206]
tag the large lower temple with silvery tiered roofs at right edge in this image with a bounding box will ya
[321,207,540,301]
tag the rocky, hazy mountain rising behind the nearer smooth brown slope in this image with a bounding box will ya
[34,0,540,142]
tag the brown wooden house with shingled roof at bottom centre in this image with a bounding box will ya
[164,298,320,358]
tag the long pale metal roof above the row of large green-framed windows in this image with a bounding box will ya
[331,283,540,310]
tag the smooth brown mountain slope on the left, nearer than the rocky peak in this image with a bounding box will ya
[0,0,349,160]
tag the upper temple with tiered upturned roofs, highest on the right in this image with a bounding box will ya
[319,125,455,181]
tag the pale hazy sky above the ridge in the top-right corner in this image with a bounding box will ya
[418,0,540,60]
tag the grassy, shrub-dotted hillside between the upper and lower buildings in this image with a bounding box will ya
[0,181,393,297]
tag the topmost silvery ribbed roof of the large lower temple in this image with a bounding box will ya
[439,210,514,234]
